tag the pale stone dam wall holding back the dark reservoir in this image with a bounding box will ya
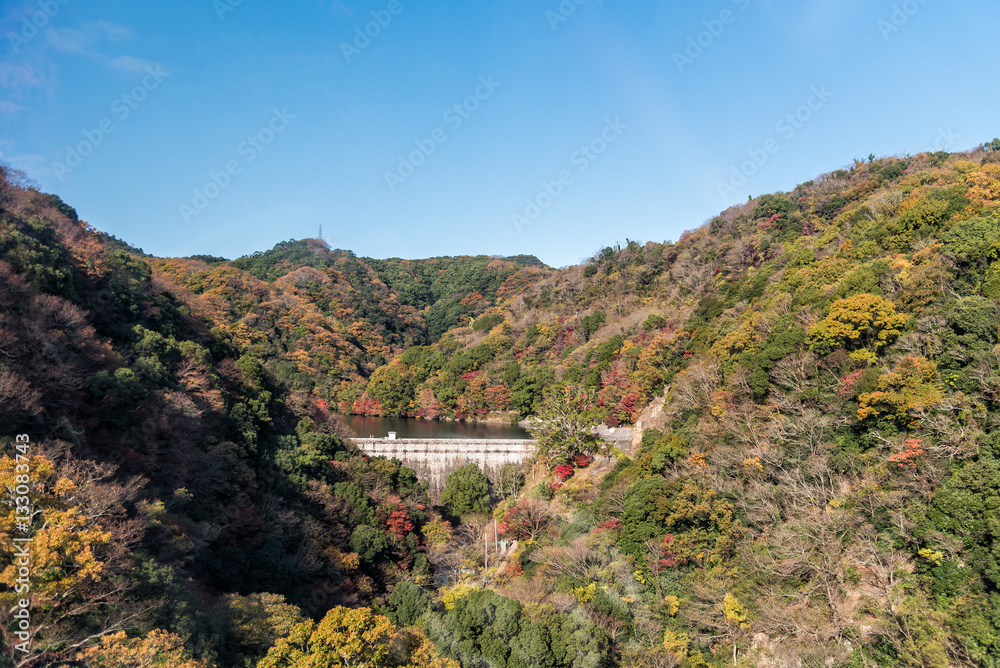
[354,438,535,494]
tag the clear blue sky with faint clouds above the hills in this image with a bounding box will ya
[0,0,1000,266]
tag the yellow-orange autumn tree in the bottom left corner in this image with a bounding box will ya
[0,444,150,665]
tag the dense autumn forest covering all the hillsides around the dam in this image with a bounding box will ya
[0,140,1000,668]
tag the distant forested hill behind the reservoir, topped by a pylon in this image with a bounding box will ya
[148,239,551,401]
